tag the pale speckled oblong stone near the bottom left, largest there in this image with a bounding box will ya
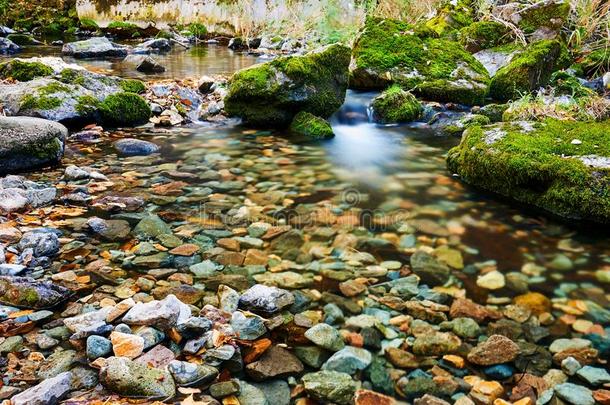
[100,357,176,399]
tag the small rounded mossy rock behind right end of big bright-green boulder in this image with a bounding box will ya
[458,21,513,53]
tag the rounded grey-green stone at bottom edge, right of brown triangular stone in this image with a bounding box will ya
[303,371,357,405]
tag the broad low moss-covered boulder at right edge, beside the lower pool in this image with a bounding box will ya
[447,120,610,224]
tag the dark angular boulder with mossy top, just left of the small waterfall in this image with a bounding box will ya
[224,44,350,127]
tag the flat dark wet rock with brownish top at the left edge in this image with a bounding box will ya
[0,276,71,309]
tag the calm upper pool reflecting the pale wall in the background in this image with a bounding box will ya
[0,44,259,80]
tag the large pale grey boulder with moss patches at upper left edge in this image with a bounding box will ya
[0,58,150,126]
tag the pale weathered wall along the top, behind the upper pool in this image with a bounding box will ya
[76,0,363,34]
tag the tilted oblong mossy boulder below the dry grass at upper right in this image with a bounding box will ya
[489,40,571,101]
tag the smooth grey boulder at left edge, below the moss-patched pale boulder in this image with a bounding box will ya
[0,117,68,175]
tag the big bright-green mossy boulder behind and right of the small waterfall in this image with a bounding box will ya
[350,18,489,104]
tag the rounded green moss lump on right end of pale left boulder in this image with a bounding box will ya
[99,93,151,127]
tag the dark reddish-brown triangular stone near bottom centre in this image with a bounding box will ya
[246,346,303,381]
